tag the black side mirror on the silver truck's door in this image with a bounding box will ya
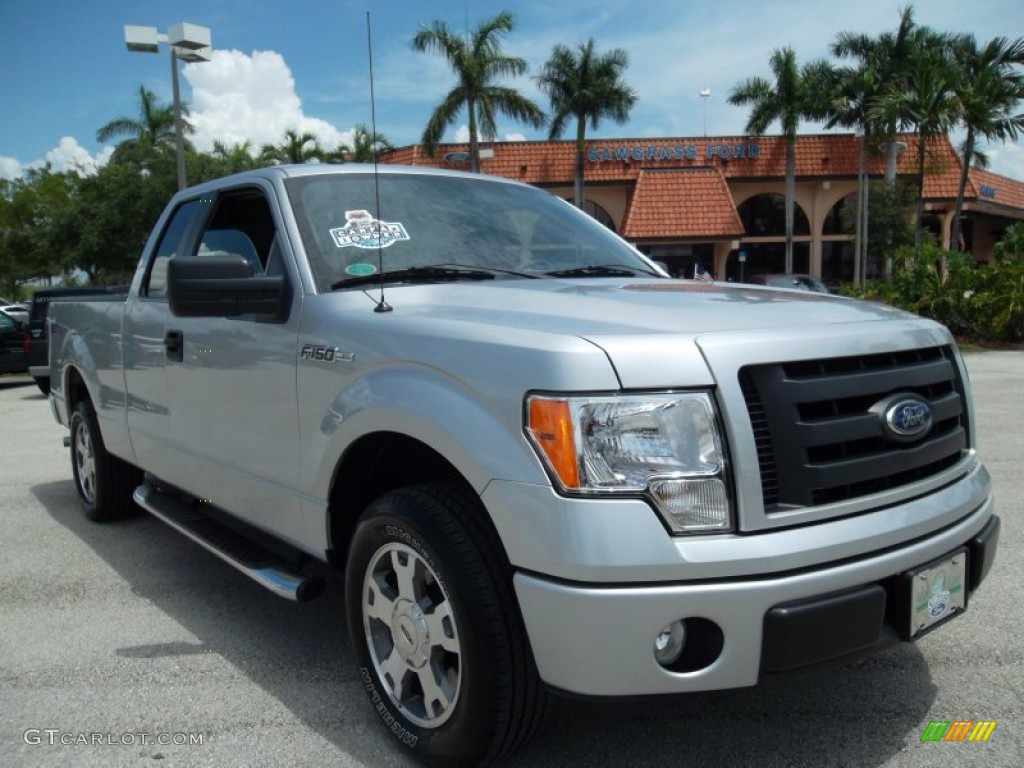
[167,256,290,319]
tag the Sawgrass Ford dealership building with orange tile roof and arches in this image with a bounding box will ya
[382,134,1024,283]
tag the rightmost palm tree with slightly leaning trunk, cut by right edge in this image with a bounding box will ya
[949,35,1024,251]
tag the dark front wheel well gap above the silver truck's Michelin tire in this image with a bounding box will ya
[328,432,475,568]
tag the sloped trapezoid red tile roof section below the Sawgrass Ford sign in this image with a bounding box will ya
[622,168,743,240]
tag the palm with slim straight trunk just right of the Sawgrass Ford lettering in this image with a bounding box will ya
[728,48,827,272]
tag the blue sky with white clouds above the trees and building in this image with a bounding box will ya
[0,0,1024,179]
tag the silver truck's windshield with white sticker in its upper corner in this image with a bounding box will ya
[287,170,662,291]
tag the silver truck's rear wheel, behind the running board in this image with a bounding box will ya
[71,400,142,522]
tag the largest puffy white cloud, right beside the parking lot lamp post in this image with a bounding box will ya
[184,50,352,152]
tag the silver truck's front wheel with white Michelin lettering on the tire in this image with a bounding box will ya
[345,484,545,766]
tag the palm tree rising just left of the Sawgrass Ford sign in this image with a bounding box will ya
[537,38,637,209]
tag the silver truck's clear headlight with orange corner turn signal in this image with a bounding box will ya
[526,392,732,534]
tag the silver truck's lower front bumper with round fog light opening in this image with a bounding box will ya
[514,497,998,696]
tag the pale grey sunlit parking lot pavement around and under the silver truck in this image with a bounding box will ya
[0,351,1024,768]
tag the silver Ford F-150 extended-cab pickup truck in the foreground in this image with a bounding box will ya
[49,166,999,764]
